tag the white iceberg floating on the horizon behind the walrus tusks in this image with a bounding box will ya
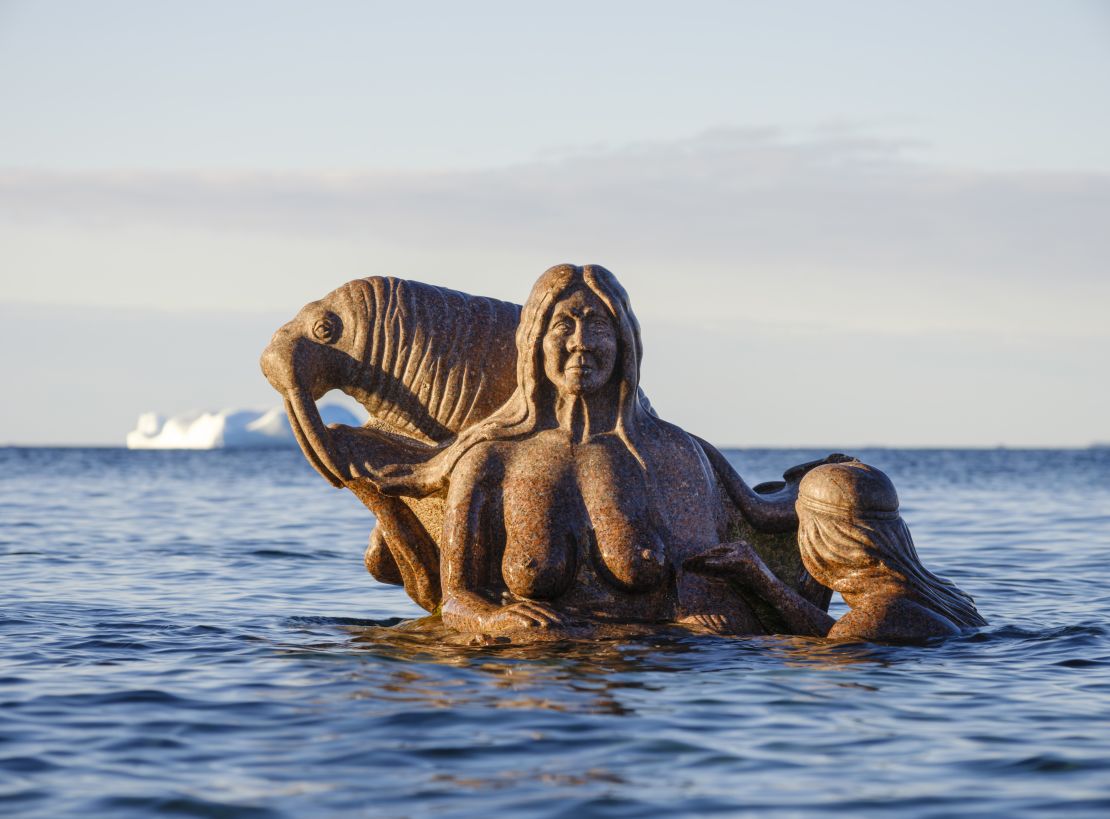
[128,404,360,449]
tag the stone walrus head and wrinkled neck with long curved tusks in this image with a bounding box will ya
[261,276,521,486]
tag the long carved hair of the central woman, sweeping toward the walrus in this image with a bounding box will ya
[374,264,655,495]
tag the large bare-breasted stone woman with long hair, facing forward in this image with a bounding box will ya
[367,265,808,633]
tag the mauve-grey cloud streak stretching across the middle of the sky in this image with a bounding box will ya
[0,130,1110,283]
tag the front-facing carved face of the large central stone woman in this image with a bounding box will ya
[544,287,617,395]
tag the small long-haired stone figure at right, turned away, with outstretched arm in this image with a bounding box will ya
[687,461,986,641]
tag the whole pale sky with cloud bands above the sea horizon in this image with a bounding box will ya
[0,0,1110,449]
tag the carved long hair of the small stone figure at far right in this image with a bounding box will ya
[797,461,986,627]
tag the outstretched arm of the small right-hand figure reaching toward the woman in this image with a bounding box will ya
[685,540,836,637]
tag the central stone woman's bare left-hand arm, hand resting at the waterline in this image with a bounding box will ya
[441,447,564,631]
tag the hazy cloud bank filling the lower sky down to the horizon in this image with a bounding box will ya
[0,131,1110,445]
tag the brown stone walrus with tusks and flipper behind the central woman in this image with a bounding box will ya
[261,276,812,611]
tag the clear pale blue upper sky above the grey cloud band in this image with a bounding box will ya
[0,0,1110,171]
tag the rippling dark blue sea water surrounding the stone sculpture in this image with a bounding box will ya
[0,449,1110,817]
